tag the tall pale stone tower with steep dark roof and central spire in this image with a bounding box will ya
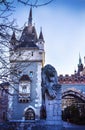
[8,8,45,120]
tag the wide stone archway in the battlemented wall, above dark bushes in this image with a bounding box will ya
[62,88,85,110]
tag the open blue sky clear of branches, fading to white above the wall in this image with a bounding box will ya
[12,0,85,75]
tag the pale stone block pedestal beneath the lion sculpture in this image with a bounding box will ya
[45,87,62,125]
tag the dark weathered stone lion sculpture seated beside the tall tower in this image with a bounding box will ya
[41,64,61,118]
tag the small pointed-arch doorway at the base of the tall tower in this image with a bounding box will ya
[25,108,35,120]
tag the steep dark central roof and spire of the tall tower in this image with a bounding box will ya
[16,7,38,49]
